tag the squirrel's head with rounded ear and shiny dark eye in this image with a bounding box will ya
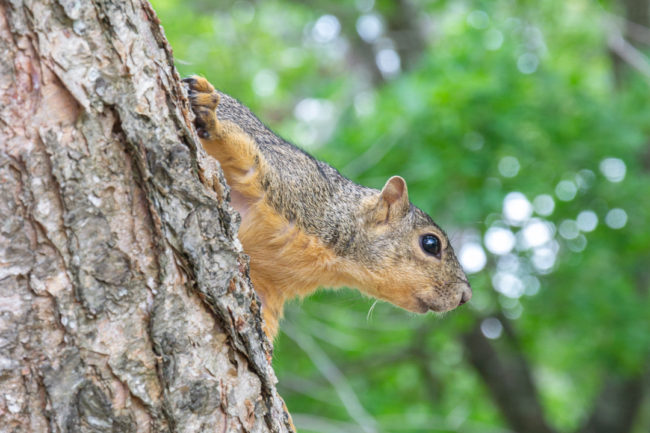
[355,176,472,313]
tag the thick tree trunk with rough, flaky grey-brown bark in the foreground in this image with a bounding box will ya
[0,0,291,432]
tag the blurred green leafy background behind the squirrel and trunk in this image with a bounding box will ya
[153,0,650,433]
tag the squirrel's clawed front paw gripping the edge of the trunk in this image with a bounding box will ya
[183,75,219,140]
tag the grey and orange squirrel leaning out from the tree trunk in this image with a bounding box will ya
[183,76,472,341]
